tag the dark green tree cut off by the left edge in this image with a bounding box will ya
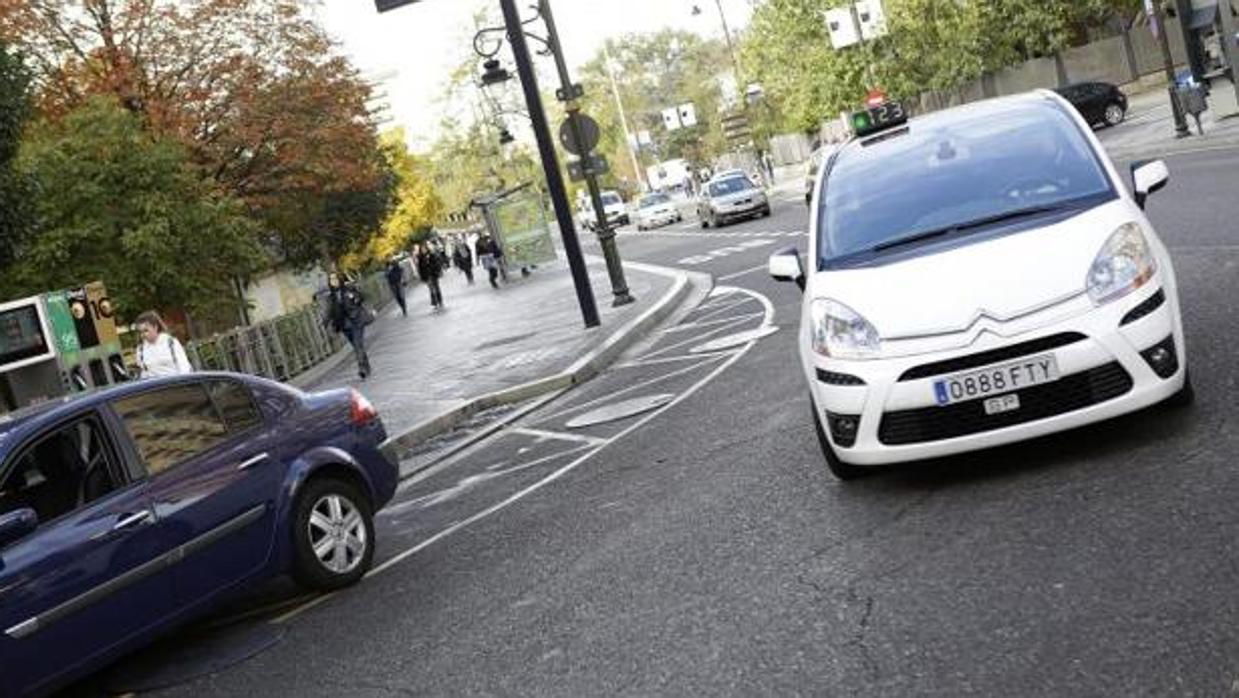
[0,42,33,267]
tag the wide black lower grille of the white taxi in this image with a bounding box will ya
[877,362,1132,446]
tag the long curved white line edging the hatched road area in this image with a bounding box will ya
[270,288,774,624]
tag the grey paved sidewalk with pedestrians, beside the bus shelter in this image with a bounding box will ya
[299,259,690,445]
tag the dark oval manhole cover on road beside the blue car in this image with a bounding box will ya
[104,622,287,694]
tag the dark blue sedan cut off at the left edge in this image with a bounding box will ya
[0,373,398,696]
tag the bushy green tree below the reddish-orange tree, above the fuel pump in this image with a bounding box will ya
[10,97,265,317]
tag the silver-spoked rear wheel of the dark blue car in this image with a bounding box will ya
[292,477,374,591]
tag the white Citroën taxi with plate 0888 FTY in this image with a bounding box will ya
[769,92,1192,479]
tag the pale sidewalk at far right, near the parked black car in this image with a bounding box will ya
[1097,86,1239,160]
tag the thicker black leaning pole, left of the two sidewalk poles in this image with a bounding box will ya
[499,0,604,327]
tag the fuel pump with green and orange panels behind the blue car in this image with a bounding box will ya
[0,281,129,419]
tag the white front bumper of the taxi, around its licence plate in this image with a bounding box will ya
[805,284,1187,465]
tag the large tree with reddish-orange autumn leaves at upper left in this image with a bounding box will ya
[0,0,393,265]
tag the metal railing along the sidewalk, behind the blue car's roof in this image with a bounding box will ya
[185,274,392,381]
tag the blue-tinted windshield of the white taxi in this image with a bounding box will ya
[818,100,1114,268]
